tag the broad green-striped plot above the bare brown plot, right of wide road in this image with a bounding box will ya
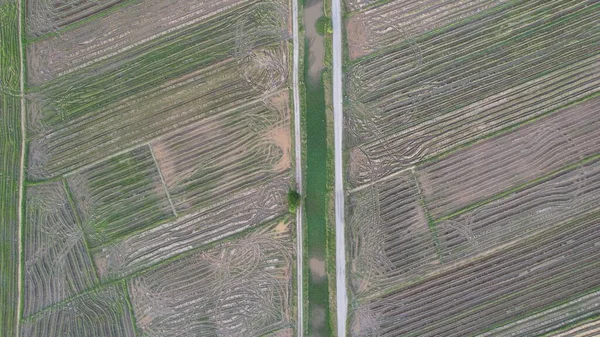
[346,1,600,186]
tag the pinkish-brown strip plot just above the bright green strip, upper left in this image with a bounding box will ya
[27,0,247,84]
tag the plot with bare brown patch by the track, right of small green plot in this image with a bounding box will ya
[151,93,291,211]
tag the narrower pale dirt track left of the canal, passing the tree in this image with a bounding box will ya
[292,0,304,337]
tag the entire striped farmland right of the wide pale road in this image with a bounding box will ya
[344,0,600,337]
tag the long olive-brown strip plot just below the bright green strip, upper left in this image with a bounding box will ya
[29,53,288,179]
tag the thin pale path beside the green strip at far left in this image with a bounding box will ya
[15,0,27,337]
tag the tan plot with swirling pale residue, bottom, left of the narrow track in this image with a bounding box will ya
[129,221,293,337]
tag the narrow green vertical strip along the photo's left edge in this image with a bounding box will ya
[0,1,22,336]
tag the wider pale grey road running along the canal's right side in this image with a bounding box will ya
[331,0,348,337]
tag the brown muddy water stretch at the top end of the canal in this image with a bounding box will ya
[304,0,325,81]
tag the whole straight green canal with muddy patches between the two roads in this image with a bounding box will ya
[304,0,332,337]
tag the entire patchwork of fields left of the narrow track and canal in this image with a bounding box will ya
[0,0,297,337]
